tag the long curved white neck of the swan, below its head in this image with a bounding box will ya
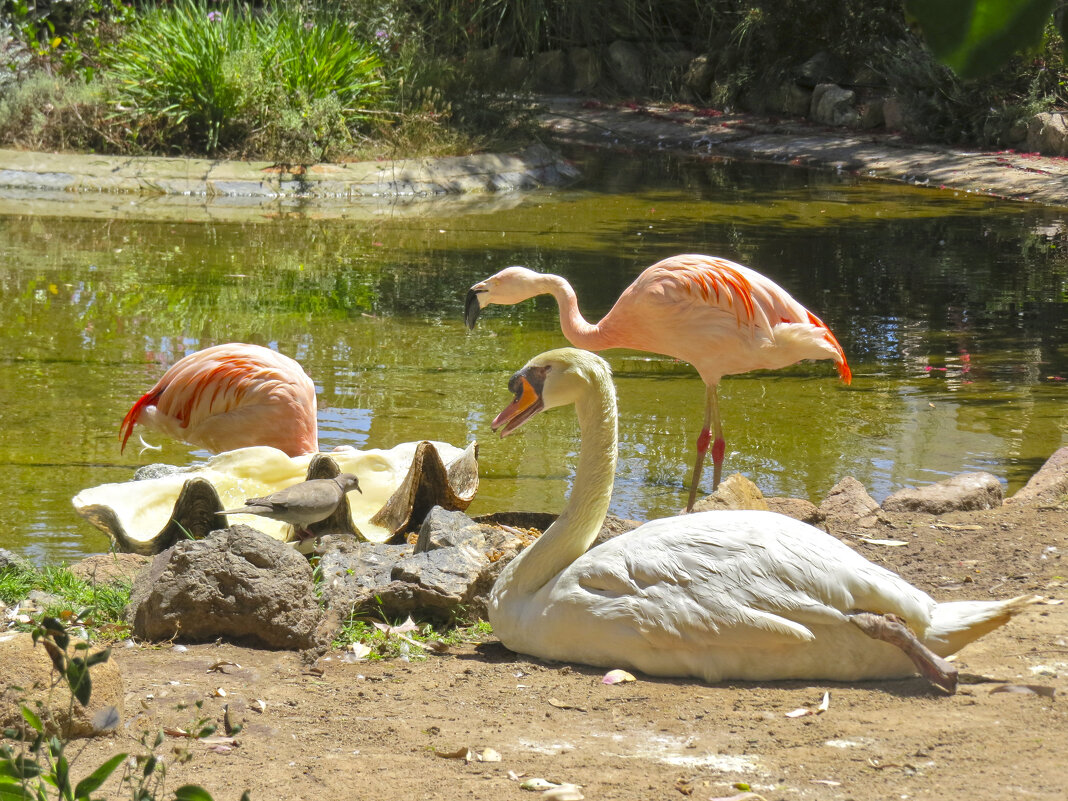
[498,369,616,599]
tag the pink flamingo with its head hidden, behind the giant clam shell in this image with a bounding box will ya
[120,342,319,456]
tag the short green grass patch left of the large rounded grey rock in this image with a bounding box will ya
[0,567,130,642]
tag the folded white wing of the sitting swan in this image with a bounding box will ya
[576,513,928,648]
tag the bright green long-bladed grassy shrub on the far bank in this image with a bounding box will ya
[103,0,382,156]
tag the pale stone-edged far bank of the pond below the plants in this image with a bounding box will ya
[6,97,1068,221]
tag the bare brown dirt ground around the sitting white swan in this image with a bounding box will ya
[60,506,1068,801]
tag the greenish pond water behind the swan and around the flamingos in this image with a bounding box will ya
[0,152,1068,563]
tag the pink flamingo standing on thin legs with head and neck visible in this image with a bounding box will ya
[465,254,852,512]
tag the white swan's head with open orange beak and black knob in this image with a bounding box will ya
[492,348,612,438]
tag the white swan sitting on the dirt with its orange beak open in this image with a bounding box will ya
[489,348,1034,692]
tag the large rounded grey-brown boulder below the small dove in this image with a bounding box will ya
[126,525,331,649]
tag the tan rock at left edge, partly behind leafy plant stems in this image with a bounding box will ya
[0,631,124,739]
